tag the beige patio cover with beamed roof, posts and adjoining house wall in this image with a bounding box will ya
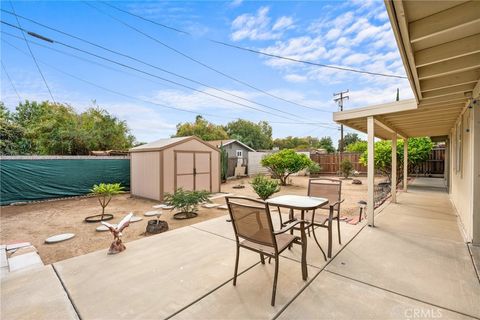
[333,0,480,243]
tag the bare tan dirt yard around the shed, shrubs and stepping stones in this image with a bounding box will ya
[0,177,367,264]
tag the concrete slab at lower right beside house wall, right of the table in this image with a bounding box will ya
[327,228,480,317]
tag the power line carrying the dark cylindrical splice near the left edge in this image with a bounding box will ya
[0,20,312,120]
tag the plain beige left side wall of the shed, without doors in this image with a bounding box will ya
[130,151,162,200]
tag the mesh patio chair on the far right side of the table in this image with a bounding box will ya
[294,178,344,260]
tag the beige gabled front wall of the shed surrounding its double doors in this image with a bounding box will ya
[163,140,220,193]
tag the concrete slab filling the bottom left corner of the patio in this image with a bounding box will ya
[0,266,78,320]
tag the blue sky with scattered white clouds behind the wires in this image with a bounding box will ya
[1,0,412,142]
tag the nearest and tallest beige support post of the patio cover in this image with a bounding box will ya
[367,116,375,227]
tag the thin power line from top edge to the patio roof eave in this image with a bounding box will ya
[101,1,408,79]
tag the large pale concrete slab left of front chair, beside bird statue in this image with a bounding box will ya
[55,227,260,319]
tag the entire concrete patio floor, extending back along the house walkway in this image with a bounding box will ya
[1,178,480,319]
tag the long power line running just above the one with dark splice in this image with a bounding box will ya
[2,9,318,119]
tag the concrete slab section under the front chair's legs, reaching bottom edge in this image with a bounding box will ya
[173,258,318,319]
